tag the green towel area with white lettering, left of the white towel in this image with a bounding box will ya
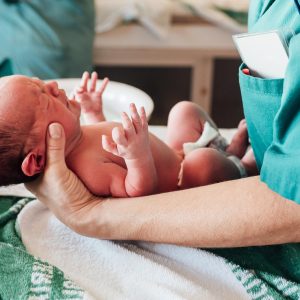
[0,196,84,300]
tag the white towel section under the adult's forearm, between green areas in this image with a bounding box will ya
[17,200,249,300]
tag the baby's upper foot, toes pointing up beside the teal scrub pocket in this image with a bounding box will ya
[226,119,249,158]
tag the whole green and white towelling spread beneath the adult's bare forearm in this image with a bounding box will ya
[0,196,300,300]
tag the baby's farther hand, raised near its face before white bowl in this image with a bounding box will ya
[74,72,109,124]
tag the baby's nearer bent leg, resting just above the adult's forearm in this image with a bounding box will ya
[180,148,240,189]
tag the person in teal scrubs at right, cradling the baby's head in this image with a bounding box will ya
[28,0,300,248]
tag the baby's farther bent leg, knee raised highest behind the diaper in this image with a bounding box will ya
[167,101,215,151]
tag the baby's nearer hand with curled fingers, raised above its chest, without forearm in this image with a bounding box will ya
[102,103,150,160]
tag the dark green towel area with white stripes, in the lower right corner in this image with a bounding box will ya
[210,244,300,300]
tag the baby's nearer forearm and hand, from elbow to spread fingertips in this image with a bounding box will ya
[102,104,157,197]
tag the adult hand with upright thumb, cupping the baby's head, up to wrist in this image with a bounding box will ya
[26,123,102,235]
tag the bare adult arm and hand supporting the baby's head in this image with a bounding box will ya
[27,124,300,247]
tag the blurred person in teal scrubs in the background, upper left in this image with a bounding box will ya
[0,0,94,79]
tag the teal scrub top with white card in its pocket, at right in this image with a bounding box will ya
[239,0,300,203]
